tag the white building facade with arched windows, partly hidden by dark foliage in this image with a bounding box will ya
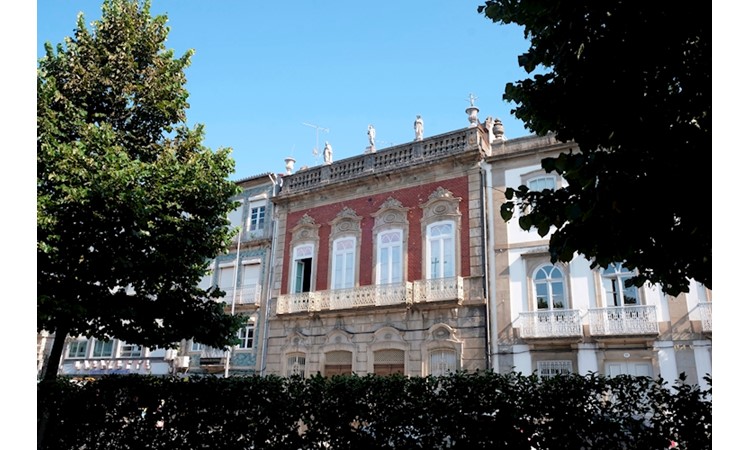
[484,136,711,388]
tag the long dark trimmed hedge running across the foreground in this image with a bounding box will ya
[37,372,712,450]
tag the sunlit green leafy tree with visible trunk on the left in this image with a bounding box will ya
[37,0,240,379]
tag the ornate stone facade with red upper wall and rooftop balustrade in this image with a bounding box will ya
[265,129,494,376]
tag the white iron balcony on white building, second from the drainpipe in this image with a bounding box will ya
[589,305,659,336]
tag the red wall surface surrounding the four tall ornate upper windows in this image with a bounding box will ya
[281,176,470,294]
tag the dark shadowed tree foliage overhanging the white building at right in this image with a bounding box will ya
[478,0,711,295]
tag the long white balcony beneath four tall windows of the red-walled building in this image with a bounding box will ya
[276,277,463,314]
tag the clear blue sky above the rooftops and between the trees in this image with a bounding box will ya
[37,0,529,180]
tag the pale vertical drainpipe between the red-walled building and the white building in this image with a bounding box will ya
[480,161,500,373]
